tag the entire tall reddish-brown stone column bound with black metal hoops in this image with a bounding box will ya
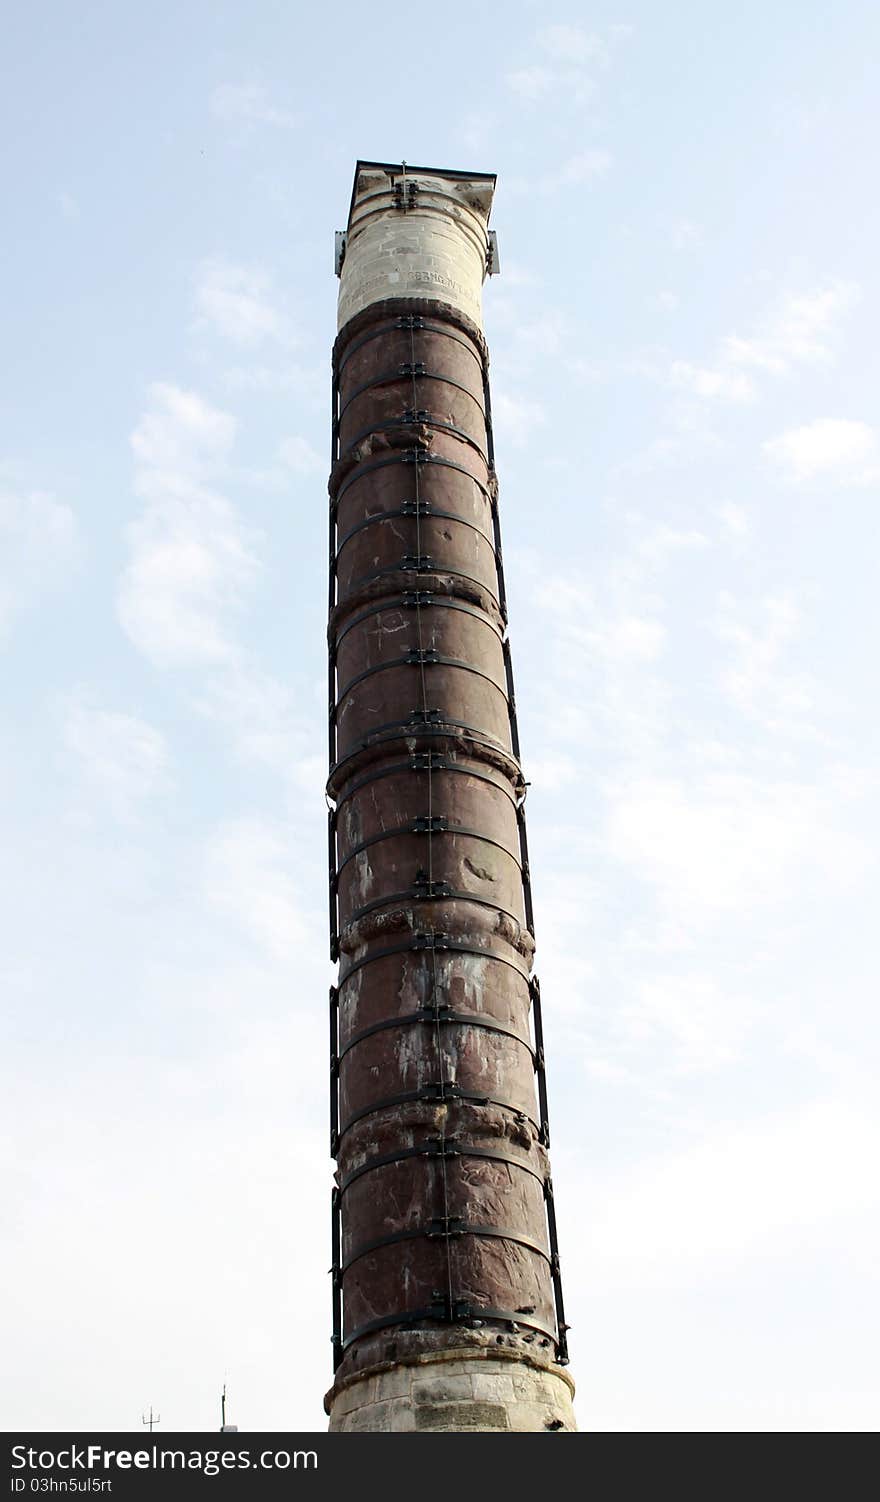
[326,162,575,1433]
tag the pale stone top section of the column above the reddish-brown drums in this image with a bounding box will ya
[338,165,494,329]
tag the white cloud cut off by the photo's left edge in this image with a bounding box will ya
[0,487,78,637]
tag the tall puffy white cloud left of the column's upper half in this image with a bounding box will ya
[117,385,257,665]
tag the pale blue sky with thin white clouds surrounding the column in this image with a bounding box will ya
[0,0,880,1430]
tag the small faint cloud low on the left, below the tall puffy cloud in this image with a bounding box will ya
[63,692,170,819]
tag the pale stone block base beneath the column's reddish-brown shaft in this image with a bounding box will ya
[324,1349,577,1434]
